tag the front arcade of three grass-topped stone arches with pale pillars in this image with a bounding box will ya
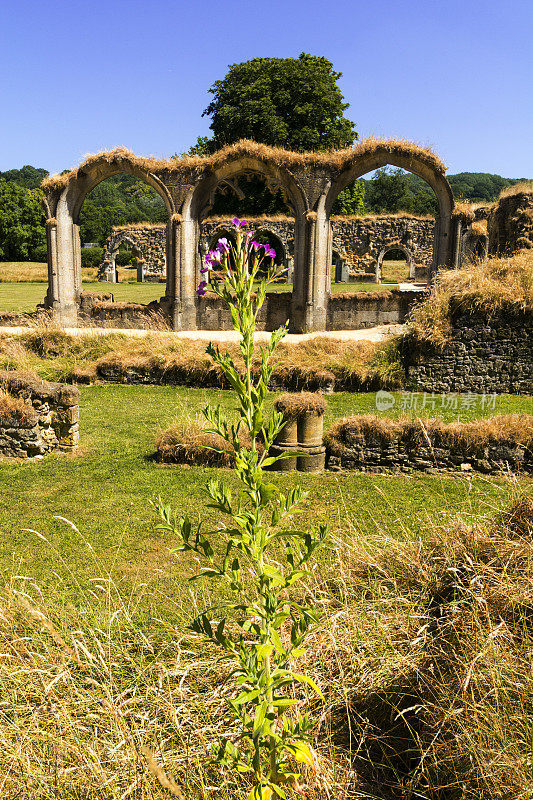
[43,141,454,333]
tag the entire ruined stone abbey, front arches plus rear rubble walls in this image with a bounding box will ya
[39,140,524,333]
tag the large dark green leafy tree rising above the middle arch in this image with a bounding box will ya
[195,53,357,153]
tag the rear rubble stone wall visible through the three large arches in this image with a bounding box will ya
[99,215,435,280]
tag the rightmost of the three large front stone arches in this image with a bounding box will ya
[326,143,454,276]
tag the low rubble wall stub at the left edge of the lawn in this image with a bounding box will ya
[0,372,79,458]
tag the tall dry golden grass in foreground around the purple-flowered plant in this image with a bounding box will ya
[0,495,533,800]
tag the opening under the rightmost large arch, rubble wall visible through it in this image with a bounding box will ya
[326,155,453,291]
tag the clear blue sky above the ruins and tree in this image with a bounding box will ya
[0,0,533,177]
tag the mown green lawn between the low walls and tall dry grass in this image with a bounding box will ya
[0,385,528,615]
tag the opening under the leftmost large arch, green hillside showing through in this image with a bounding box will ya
[73,172,168,303]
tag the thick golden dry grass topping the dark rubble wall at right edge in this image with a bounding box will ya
[409,250,533,346]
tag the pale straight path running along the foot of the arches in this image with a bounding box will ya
[0,325,406,344]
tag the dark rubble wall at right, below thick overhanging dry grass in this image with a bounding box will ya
[404,312,533,394]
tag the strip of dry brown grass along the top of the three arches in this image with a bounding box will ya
[42,136,446,192]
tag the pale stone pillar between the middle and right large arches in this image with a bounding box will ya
[290,202,331,333]
